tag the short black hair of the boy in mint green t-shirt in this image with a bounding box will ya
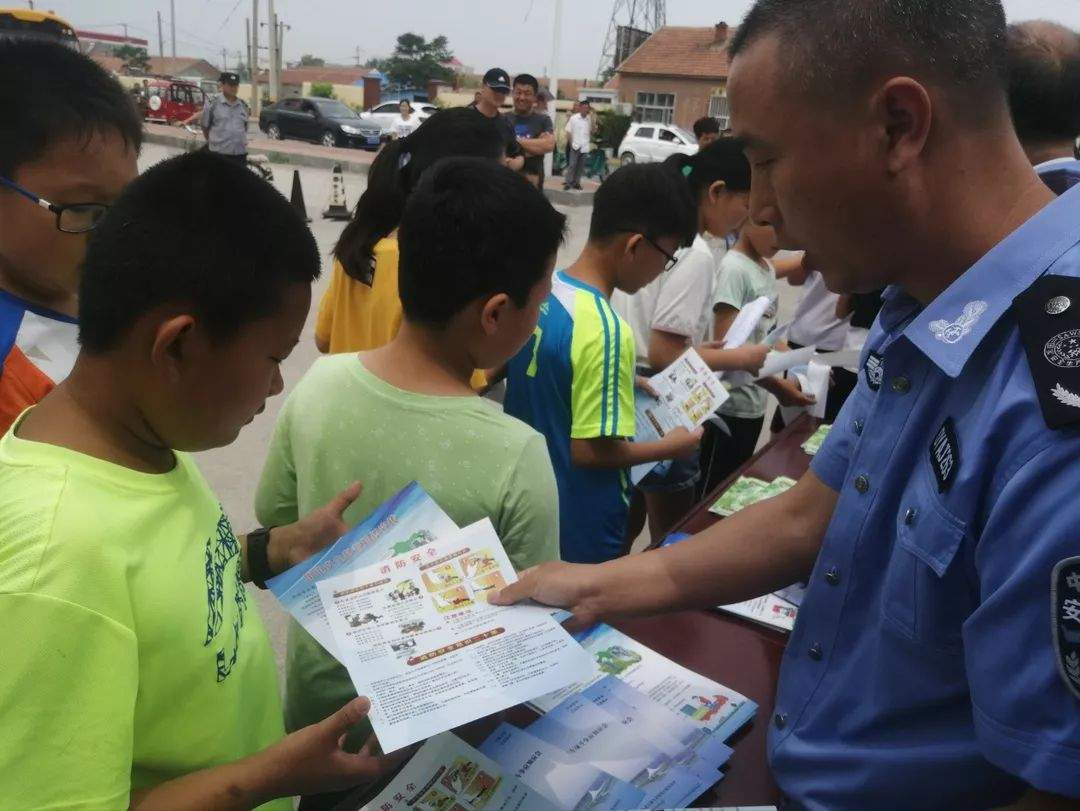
[397,158,566,326]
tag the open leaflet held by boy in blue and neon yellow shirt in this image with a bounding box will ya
[630,349,730,484]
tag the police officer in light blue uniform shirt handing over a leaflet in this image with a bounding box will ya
[491,0,1080,811]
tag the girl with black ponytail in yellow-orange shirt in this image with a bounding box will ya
[315,108,503,388]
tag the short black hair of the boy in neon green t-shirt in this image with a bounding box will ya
[79,151,320,352]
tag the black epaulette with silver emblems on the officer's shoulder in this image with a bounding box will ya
[1013,275,1080,429]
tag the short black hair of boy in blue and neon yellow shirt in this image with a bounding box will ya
[589,163,698,245]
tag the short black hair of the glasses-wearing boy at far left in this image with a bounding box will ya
[0,38,143,177]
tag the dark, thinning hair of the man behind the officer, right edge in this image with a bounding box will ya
[1008,21,1080,141]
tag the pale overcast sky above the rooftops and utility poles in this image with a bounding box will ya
[50,0,1080,78]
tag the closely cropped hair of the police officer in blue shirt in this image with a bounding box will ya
[729,0,1005,122]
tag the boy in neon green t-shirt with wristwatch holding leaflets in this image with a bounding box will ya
[0,153,403,811]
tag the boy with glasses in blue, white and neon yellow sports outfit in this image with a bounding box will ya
[505,164,701,563]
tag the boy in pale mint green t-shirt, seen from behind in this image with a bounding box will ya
[256,158,565,799]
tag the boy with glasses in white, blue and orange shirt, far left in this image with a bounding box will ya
[0,40,143,432]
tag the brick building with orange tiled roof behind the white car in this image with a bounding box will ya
[609,23,731,130]
